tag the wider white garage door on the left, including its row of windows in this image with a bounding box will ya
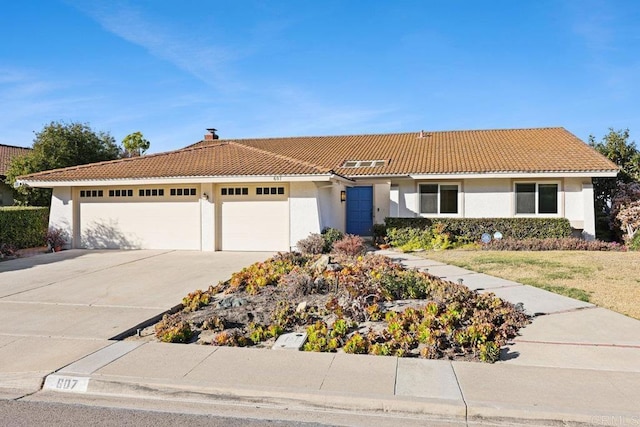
[78,188,200,250]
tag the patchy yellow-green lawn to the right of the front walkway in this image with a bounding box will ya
[420,250,640,319]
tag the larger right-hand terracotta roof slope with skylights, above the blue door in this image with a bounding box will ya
[199,128,617,176]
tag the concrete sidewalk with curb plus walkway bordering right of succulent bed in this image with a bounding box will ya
[0,251,640,425]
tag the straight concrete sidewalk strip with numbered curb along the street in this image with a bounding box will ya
[44,342,640,425]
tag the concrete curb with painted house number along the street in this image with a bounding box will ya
[43,374,640,426]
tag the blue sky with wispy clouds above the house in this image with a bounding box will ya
[0,0,640,152]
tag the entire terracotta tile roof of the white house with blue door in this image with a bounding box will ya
[21,128,618,182]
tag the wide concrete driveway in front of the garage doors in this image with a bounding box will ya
[0,250,272,394]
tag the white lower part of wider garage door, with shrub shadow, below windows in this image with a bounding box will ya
[80,202,200,250]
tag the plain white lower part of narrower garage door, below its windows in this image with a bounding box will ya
[221,200,289,251]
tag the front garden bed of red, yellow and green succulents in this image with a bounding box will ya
[132,253,529,362]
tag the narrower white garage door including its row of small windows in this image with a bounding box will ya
[218,185,289,251]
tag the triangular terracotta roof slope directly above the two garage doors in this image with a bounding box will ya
[20,141,330,181]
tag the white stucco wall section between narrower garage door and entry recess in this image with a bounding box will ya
[289,182,322,248]
